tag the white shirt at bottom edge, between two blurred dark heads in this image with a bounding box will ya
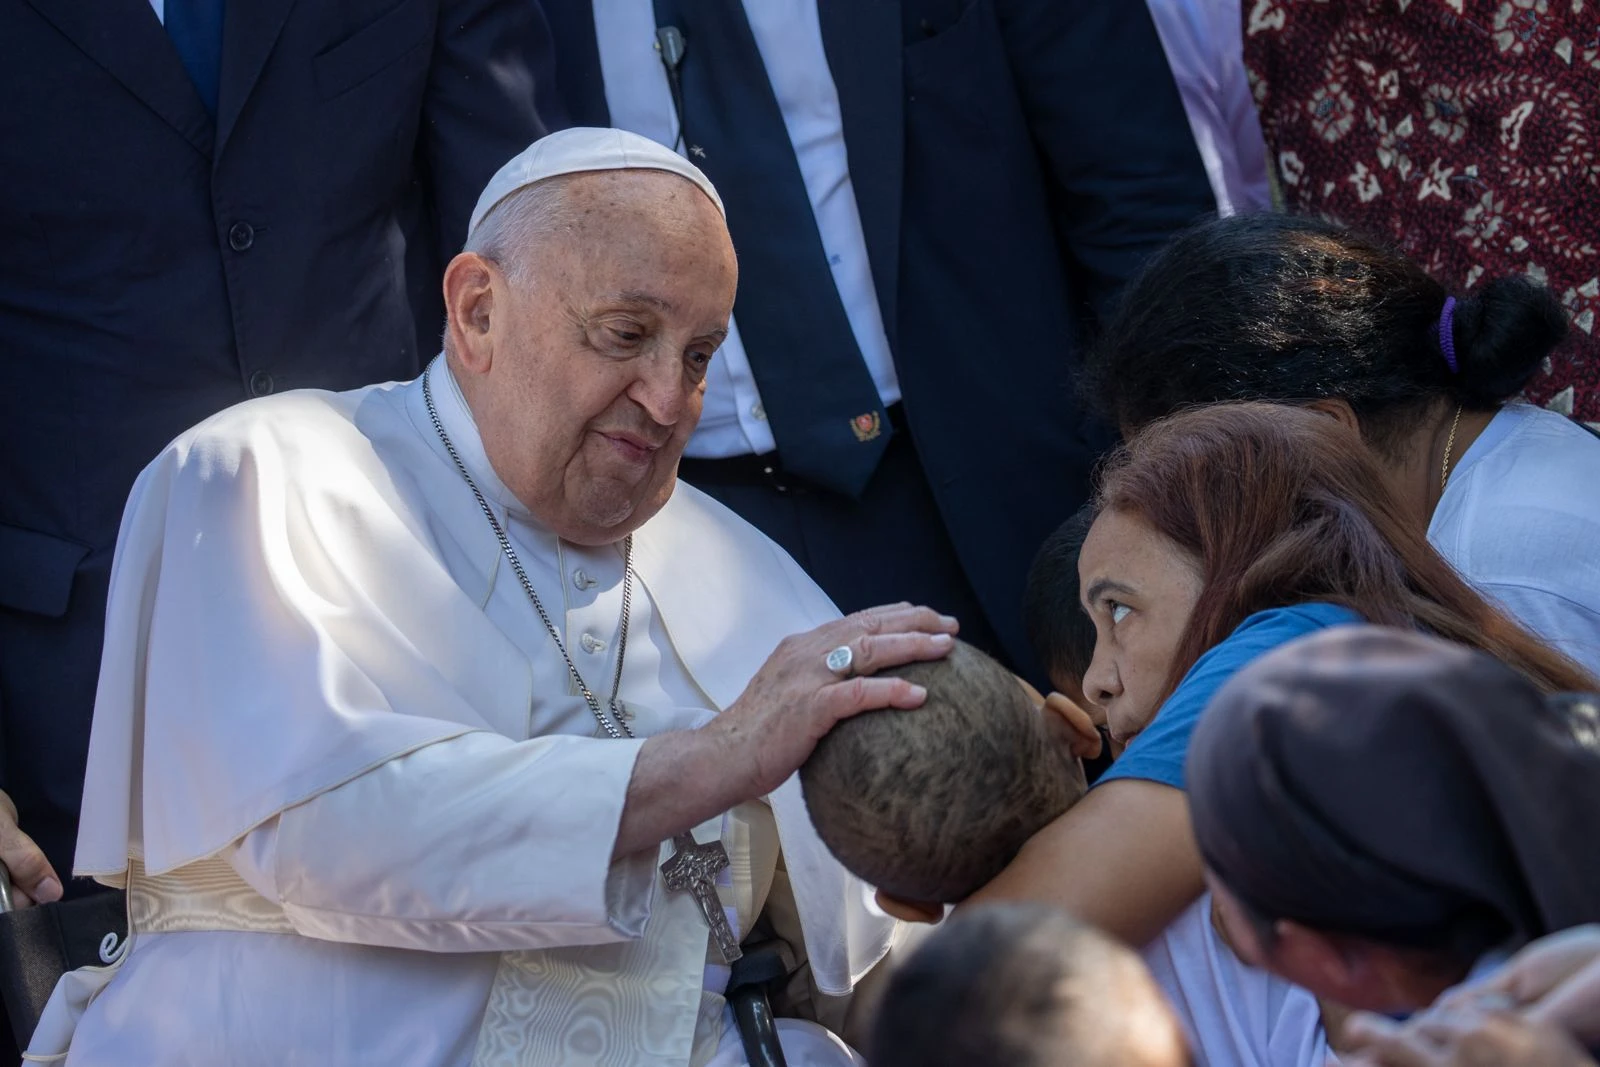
[1144,893,1339,1067]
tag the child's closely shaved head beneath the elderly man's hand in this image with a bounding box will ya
[800,641,1082,904]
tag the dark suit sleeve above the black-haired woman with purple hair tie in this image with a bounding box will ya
[995,0,1216,315]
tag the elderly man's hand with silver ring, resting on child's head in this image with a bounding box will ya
[701,603,958,797]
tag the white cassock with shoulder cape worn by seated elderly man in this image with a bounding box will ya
[32,360,893,1067]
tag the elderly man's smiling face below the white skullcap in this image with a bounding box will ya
[446,171,738,544]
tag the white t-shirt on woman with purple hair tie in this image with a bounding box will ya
[1427,403,1600,673]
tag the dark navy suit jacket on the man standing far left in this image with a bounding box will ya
[0,0,550,875]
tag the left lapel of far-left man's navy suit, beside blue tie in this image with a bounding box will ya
[27,0,213,157]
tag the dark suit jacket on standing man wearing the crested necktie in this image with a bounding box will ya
[546,0,1214,675]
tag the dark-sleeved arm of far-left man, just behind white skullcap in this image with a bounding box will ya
[421,0,566,255]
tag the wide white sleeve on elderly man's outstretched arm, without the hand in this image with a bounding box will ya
[224,733,659,952]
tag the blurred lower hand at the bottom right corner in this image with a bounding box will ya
[1346,1006,1595,1067]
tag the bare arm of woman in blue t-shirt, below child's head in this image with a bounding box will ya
[971,779,1205,947]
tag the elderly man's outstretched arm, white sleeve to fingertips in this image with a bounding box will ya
[226,605,955,952]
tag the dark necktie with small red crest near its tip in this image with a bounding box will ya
[654,0,893,498]
